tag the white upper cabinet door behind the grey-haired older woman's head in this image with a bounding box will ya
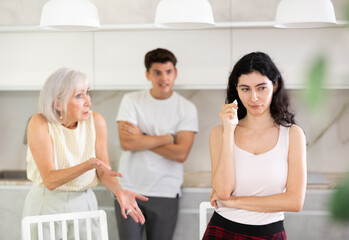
[0,32,93,90]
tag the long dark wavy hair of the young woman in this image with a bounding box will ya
[225,52,295,127]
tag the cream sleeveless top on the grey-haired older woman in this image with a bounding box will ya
[27,111,98,191]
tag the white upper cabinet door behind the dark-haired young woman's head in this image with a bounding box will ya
[232,28,349,88]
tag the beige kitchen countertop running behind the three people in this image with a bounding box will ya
[0,172,346,189]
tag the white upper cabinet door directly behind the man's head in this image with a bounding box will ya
[95,29,231,89]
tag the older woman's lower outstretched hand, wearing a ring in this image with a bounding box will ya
[116,189,148,224]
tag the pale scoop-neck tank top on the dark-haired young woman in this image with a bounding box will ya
[216,126,289,225]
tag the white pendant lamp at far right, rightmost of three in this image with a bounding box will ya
[274,0,336,28]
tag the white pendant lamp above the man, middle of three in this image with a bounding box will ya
[154,0,215,29]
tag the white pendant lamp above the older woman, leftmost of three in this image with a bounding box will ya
[39,0,100,31]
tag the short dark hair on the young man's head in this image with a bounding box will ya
[144,48,177,71]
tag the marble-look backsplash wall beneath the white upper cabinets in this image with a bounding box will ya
[0,90,349,172]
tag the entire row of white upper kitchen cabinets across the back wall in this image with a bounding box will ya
[0,23,349,90]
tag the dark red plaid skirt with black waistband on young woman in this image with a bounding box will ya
[202,212,287,240]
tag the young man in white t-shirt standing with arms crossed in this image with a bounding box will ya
[115,48,198,240]
